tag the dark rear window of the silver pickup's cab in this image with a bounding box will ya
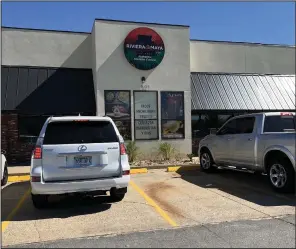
[264,116,296,132]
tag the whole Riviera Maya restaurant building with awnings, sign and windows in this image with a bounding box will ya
[1,19,295,164]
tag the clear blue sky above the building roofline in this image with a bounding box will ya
[2,2,295,45]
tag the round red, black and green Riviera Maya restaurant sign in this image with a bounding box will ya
[124,28,164,70]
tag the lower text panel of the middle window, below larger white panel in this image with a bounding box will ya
[135,120,158,140]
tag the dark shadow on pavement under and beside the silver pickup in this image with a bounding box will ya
[177,169,296,207]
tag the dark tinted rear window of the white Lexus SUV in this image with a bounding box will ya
[43,121,118,144]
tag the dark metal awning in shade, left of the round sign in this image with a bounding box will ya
[1,66,96,114]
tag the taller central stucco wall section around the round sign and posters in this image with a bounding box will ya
[93,21,191,154]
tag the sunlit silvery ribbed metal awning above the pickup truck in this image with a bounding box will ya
[191,73,296,110]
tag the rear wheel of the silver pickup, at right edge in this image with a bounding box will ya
[267,158,295,193]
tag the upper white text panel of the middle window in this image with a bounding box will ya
[134,92,158,119]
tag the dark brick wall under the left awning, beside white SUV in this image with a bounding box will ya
[1,114,34,166]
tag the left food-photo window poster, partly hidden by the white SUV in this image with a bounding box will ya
[105,90,131,140]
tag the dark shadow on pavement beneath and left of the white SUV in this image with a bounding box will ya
[1,182,117,221]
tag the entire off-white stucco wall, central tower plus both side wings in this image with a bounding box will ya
[1,20,295,158]
